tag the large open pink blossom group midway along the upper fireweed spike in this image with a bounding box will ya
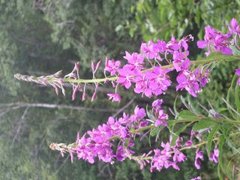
[105,35,208,101]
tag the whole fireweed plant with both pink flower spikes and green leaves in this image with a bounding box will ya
[15,19,240,179]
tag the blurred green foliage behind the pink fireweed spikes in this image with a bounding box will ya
[0,0,240,180]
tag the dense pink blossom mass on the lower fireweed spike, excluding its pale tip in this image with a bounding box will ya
[71,107,149,163]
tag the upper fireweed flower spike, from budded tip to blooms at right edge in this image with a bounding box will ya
[16,19,240,102]
